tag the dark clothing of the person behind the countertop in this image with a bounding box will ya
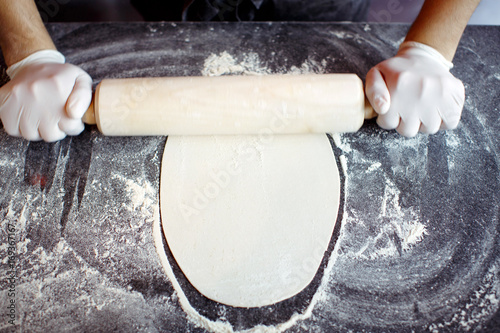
[132,0,370,21]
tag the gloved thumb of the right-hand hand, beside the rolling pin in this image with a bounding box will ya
[366,67,391,114]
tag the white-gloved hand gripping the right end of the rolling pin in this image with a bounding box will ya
[366,42,465,137]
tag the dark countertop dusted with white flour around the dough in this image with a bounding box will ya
[0,23,500,332]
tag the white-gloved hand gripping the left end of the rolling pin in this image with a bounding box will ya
[0,50,92,142]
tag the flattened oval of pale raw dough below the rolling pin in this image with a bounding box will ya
[160,135,340,307]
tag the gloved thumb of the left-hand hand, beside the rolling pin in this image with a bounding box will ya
[66,71,92,119]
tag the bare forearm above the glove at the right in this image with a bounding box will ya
[405,0,480,61]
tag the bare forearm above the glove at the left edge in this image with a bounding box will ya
[0,0,56,66]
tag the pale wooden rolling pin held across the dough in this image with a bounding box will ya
[83,74,373,136]
